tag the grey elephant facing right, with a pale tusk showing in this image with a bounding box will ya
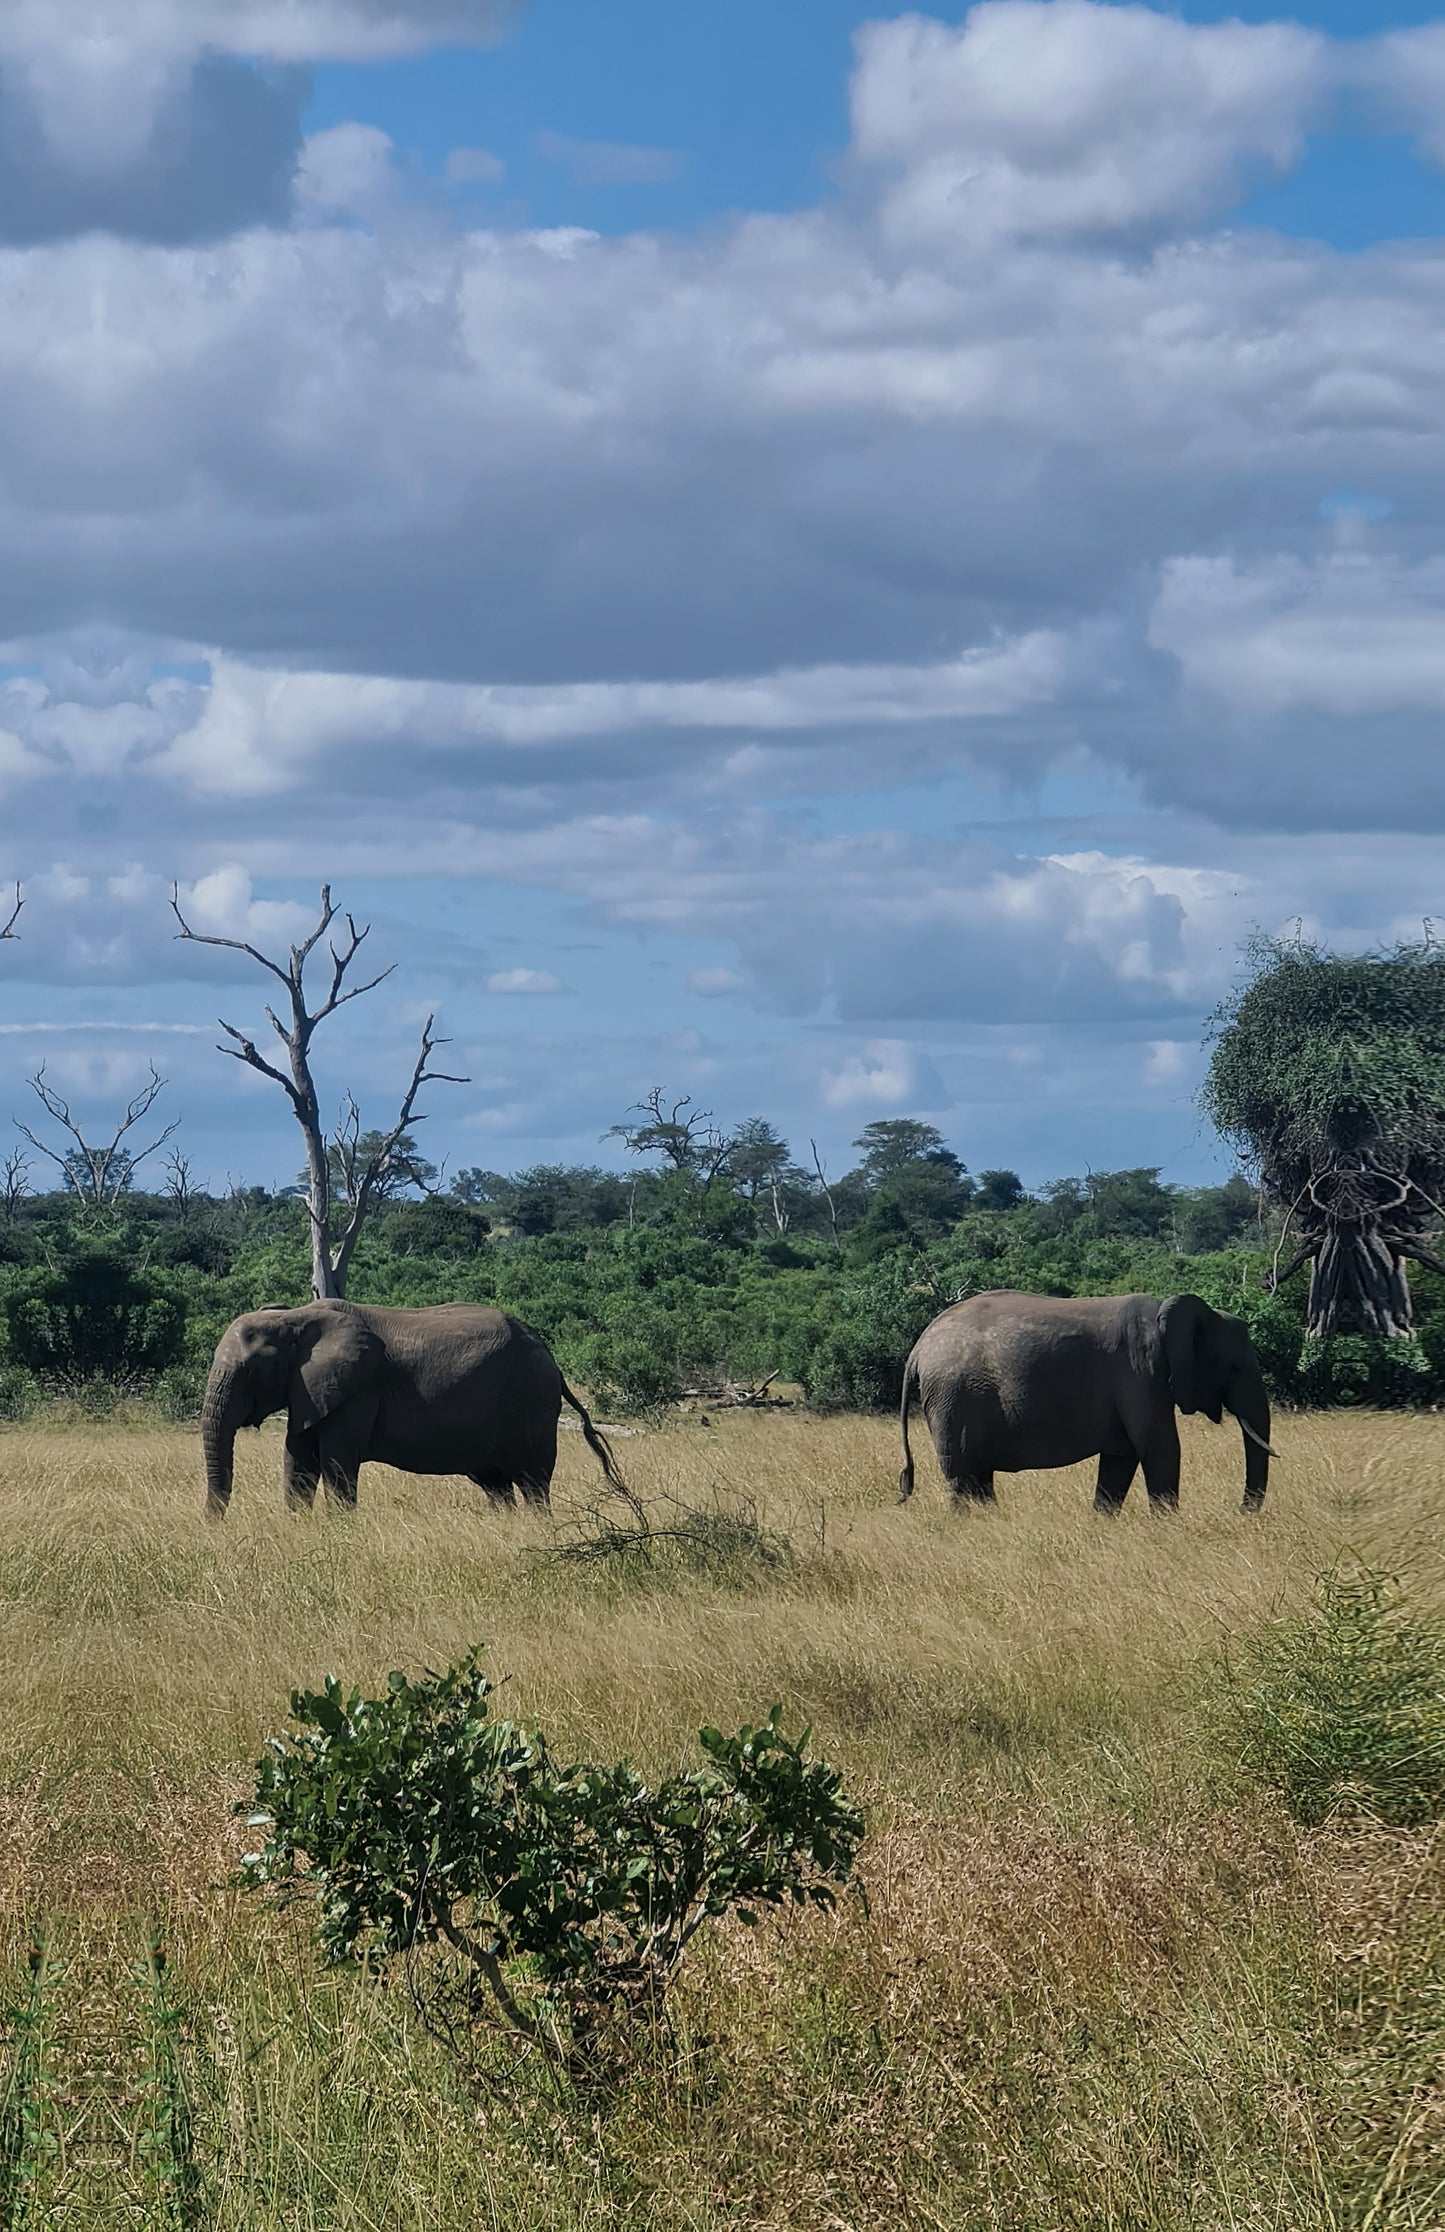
[898,1290,1273,1516]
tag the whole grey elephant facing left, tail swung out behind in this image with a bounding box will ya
[201,1301,621,1518]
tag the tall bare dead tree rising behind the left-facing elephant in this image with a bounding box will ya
[170,884,471,1299]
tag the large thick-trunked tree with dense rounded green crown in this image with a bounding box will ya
[1202,926,1445,1337]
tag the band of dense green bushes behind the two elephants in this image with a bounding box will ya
[0,1118,1445,1417]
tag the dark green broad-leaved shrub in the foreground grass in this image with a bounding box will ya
[239,1652,862,2076]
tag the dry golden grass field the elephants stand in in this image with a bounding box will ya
[0,1413,1445,2232]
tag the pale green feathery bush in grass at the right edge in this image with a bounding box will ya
[1210,1567,1445,1828]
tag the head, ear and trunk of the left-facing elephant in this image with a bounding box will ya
[201,1301,382,1518]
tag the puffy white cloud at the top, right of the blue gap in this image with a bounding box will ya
[853,0,1329,243]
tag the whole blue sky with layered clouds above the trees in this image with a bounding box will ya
[0,0,1445,1181]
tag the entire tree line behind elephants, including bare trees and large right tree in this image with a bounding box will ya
[0,886,1445,1404]
